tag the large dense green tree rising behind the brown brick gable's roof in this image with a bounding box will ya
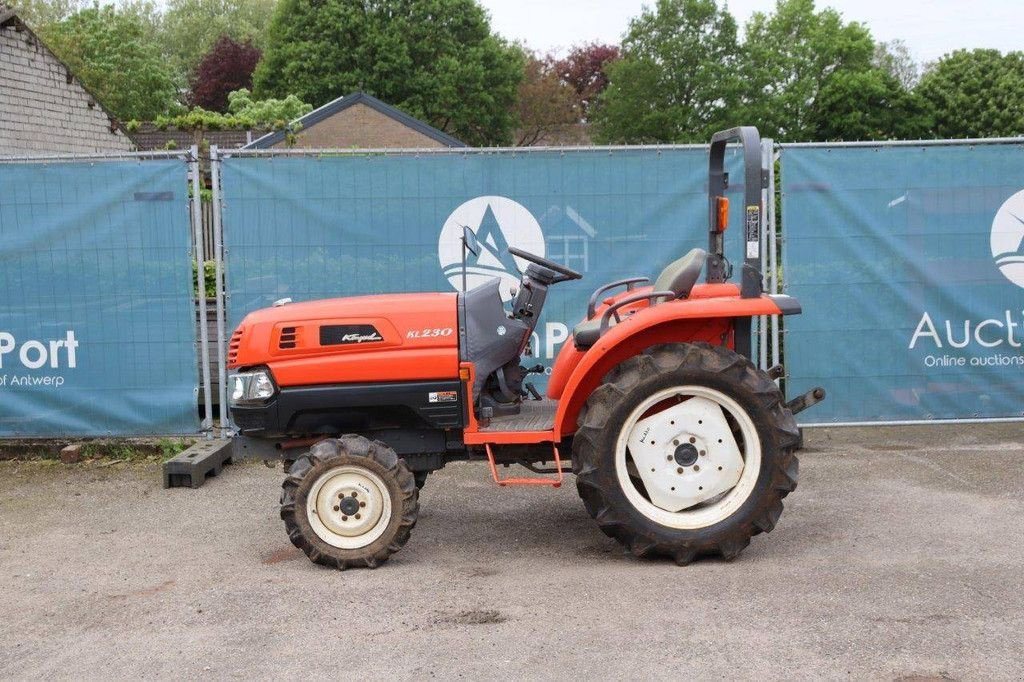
[253,0,523,145]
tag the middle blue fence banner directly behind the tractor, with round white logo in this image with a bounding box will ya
[220,145,770,390]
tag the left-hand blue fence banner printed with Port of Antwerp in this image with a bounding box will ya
[0,155,199,436]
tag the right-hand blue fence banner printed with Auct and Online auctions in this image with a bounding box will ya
[781,140,1024,424]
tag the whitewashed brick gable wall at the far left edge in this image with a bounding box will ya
[0,16,133,156]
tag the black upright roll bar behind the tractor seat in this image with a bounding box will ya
[708,126,763,298]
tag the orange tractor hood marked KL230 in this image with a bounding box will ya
[227,293,459,385]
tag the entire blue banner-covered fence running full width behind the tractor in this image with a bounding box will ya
[0,140,1024,436]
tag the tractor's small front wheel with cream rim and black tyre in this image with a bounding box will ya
[281,435,419,568]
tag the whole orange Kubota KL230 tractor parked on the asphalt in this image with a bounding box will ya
[228,127,823,568]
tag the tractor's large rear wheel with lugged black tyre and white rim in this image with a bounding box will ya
[572,343,799,564]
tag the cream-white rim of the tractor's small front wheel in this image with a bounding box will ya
[306,465,391,549]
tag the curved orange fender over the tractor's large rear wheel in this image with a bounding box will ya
[549,296,786,440]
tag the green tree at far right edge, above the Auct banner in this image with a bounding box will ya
[916,49,1024,138]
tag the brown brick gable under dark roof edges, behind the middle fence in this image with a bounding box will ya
[274,103,445,150]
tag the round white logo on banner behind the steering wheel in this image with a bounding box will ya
[437,197,545,301]
